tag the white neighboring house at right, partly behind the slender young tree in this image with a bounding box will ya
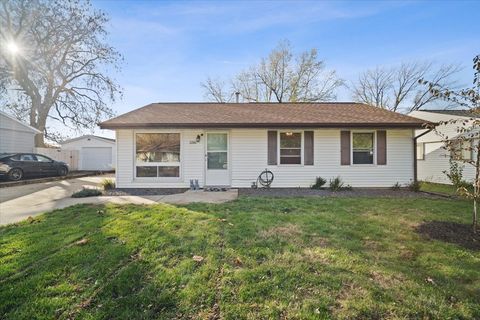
[409,110,475,184]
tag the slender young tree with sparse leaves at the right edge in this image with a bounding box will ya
[418,55,480,233]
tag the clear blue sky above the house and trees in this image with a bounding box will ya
[92,0,480,136]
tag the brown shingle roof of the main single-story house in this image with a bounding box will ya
[100,102,426,129]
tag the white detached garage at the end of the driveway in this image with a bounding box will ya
[60,135,116,171]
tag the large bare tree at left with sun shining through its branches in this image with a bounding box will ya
[0,0,121,146]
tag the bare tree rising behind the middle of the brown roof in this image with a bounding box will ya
[202,41,343,103]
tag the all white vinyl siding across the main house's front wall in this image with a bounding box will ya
[116,129,414,188]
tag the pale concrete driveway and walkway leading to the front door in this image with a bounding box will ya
[0,176,238,225]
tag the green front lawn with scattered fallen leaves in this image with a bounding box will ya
[0,198,480,319]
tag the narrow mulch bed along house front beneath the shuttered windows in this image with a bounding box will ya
[238,188,440,198]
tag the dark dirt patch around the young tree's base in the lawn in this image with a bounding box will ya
[416,221,480,250]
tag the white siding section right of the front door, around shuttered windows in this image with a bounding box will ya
[231,129,413,187]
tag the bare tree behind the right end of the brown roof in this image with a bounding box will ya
[352,62,460,111]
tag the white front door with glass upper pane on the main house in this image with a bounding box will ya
[205,132,230,186]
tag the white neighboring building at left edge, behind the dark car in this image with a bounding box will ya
[0,111,41,153]
